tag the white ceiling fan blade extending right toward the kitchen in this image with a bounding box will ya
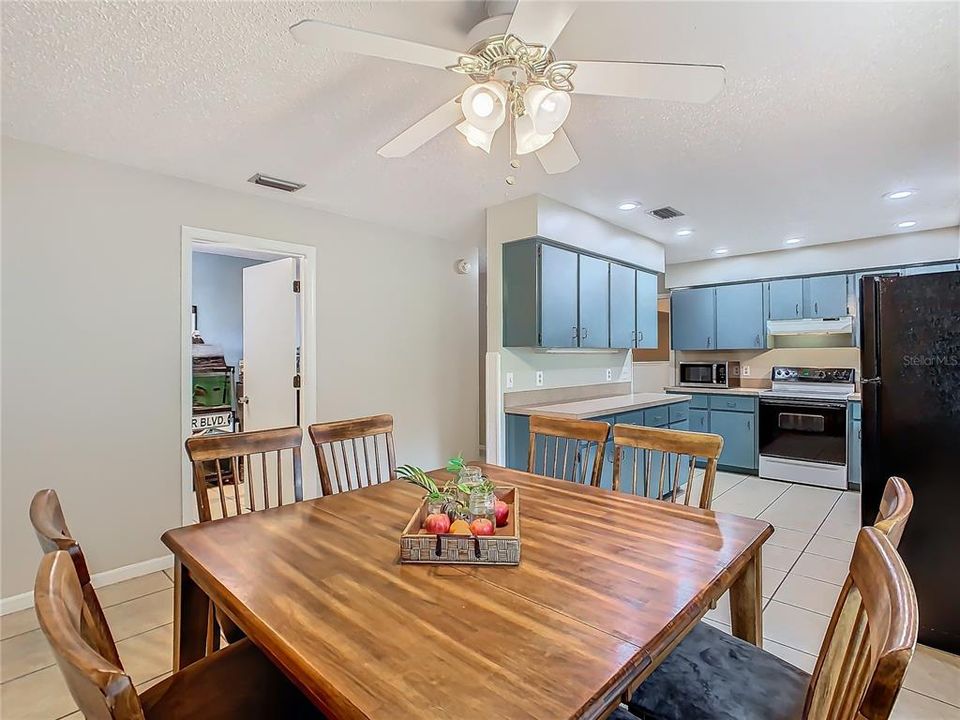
[571,60,727,103]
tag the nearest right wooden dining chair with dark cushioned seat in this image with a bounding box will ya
[628,527,918,720]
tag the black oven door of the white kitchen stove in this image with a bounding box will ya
[759,396,847,465]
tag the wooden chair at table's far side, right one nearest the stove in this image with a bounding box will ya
[613,424,723,510]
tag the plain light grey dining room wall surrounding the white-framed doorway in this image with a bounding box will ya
[0,138,479,597]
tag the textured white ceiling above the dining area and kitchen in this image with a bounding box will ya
[2,2,960,262]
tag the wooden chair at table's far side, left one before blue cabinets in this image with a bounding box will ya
[527,415,610,487]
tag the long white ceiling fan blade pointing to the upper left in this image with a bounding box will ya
[290,20,464,70]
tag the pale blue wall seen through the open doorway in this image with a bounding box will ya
[193,252,263,368]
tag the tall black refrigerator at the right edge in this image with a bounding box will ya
[860,272,960,653]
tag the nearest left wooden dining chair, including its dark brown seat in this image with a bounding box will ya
[34,551,322,720]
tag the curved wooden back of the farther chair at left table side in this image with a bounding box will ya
[30,490,123,669]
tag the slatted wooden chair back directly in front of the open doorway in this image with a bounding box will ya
[185,427,303,522]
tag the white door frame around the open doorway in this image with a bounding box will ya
[180,225,320,525]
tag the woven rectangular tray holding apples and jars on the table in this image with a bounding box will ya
[400,487,520,565]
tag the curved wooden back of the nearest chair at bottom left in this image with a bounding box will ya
[34,551,144,720]
